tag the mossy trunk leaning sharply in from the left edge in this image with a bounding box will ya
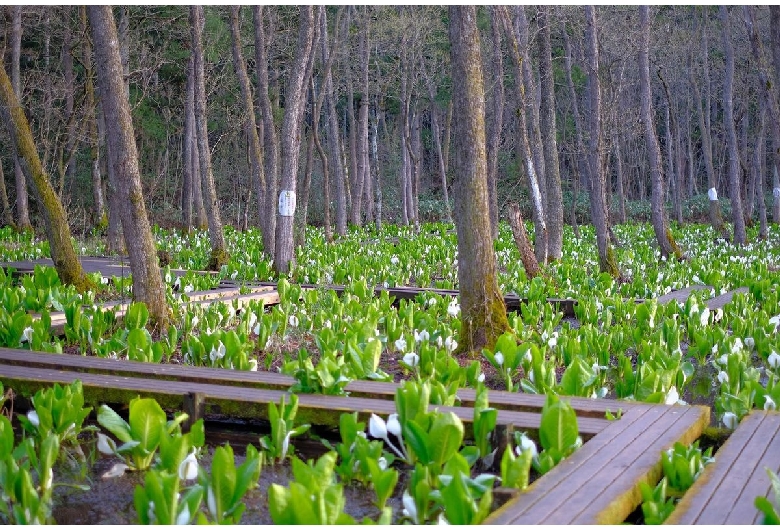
[0,67,94,292]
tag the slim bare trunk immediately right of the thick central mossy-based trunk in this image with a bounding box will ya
[487,6,505,239]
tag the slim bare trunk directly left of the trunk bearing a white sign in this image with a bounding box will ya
[252,5,279,257]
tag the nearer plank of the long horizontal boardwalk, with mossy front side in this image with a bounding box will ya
[0,365,610,434]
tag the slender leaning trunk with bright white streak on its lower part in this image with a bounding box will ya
[498,7,547,263]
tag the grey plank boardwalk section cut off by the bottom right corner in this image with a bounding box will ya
[665,410,780,525]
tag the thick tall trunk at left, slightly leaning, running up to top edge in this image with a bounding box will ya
[87,6,170,329]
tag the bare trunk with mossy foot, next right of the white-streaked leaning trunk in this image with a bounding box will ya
[585,6,620,278]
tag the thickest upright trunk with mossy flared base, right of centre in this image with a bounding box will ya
[449,6,510,354]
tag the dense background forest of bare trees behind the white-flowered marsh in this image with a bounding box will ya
[0,6,780,258]
